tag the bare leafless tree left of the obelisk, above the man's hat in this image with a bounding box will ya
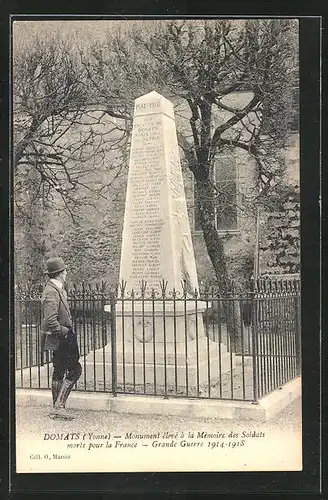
[13,23,132,281]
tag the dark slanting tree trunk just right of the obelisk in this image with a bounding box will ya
[196,179,242,352]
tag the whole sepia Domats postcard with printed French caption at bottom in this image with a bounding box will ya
[12,17,303,474]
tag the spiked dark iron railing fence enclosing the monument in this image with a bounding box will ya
[15,279,301,401]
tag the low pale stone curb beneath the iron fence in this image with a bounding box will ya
[16,377,301,422]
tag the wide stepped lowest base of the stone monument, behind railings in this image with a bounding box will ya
[85,337,236,391]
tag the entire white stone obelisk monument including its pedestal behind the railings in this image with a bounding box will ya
[88,92,229,387]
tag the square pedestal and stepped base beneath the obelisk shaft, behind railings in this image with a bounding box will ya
[86,301,235,391]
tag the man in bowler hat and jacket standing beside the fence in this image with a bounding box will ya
[41,257,82,420]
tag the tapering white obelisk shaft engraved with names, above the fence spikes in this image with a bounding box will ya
[120,92,198,293]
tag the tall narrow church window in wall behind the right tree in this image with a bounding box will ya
[195,151,238,231]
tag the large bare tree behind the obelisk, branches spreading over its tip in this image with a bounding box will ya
[89,19,297,288]
